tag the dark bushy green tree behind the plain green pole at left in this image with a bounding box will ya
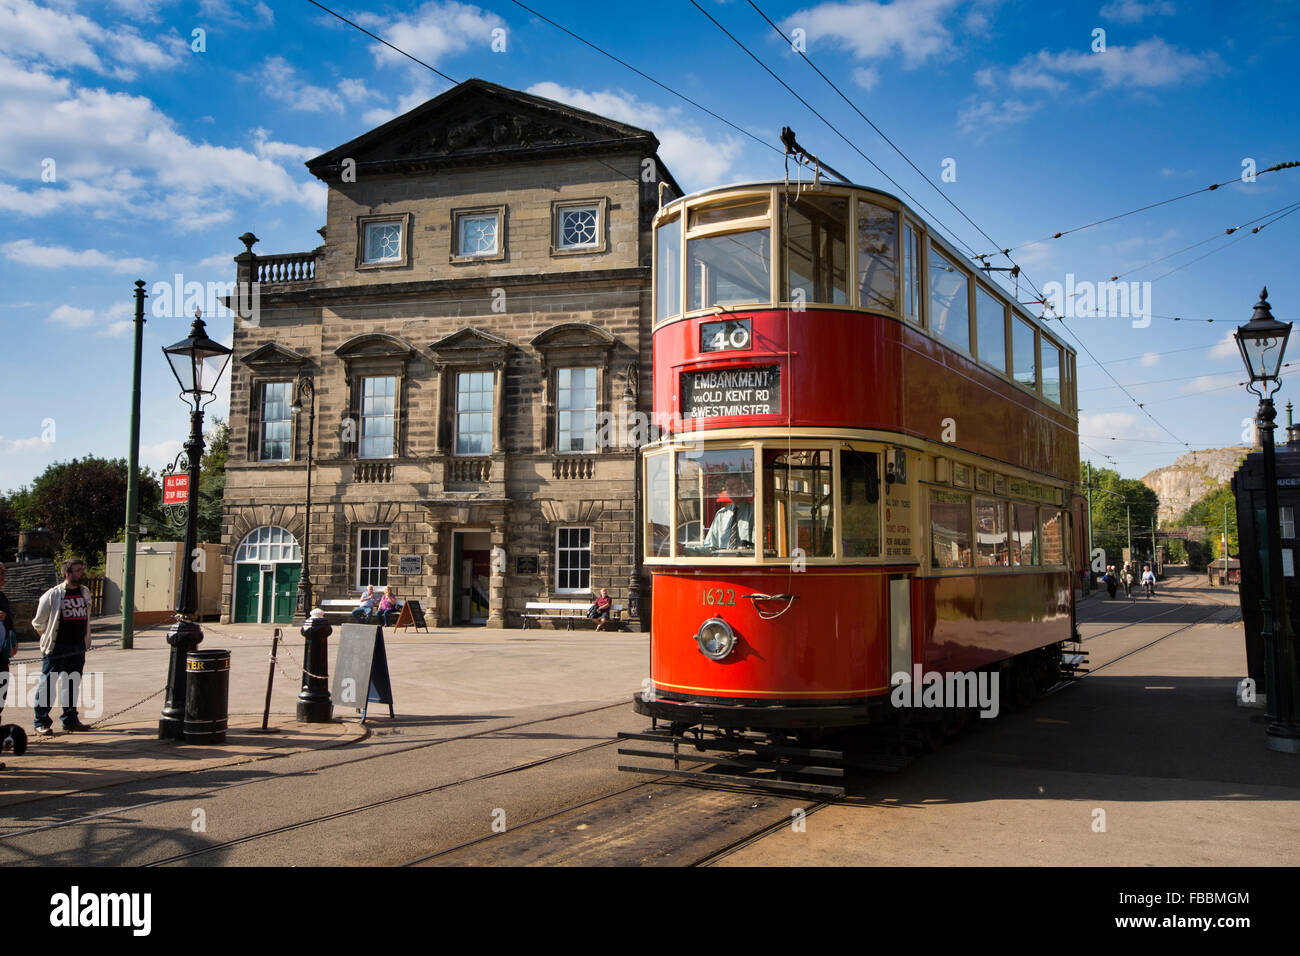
[9,455,163,568]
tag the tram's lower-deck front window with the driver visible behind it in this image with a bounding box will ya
[677,449,755,558]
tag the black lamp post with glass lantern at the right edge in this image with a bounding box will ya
[1235,287,1300,753]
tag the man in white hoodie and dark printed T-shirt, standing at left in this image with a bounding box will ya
[31,558,90,735]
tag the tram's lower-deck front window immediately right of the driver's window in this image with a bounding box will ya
[763,449,835,558]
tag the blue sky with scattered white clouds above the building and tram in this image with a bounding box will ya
[0,0,1300,490]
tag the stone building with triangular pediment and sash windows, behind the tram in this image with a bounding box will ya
[222,79,680,627]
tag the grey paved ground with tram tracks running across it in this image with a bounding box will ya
[0,579,1300,865]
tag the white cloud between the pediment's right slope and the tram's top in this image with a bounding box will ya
[528,81,741,182]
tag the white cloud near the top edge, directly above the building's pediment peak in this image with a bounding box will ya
[354,0,508,69]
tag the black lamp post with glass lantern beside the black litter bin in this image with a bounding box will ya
[159,308,231,740]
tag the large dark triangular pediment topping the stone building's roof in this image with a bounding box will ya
[307,79,659,178]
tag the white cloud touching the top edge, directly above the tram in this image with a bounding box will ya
[781,0,957,66]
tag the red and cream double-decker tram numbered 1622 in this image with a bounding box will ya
[628,175,1079,790]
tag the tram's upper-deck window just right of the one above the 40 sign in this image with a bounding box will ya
[781,195,849,306]
